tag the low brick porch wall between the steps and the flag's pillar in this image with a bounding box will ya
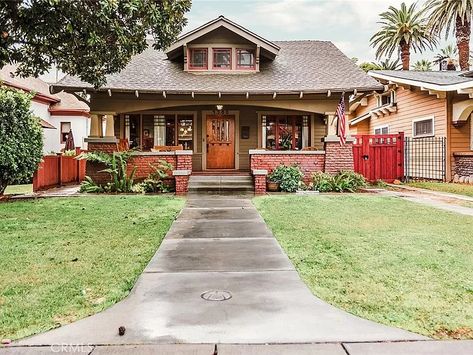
[250,152,325,184]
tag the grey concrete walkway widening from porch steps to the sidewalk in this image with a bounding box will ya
[7,196,473,355]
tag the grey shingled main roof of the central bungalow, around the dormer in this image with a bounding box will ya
[53,41,383,94]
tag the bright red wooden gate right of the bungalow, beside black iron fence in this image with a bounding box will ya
[353,132,404,182]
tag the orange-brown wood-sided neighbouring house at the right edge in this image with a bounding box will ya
[350,71,473,183]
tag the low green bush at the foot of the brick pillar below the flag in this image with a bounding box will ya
[312,171,366,192]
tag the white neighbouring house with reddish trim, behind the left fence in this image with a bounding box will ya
[0,65,90,154]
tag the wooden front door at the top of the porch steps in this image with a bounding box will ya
[207,115,235,169]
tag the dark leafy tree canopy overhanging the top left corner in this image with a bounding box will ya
[0,0,191,87]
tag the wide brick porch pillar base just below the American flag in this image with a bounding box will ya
[324,137,354,174]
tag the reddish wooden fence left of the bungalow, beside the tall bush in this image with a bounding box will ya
[33,155,86,191]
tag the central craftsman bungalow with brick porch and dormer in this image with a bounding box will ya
[53,16,383,192]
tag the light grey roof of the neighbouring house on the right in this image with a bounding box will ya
[368,70,473,91]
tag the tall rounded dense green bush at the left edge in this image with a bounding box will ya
[0,87,43,196]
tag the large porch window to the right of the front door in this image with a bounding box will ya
[266,116,302,150]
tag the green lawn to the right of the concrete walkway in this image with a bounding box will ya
[254,194,473,338]
